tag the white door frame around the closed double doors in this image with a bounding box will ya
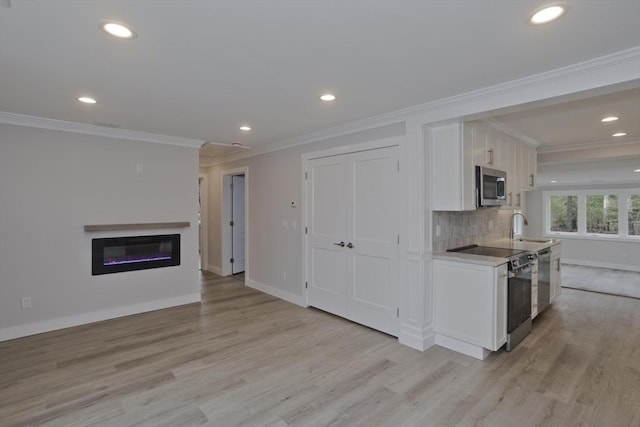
[300,135,405,306]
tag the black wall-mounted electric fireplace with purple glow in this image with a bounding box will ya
[91,234,180,276]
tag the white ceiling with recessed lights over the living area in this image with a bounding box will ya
[0,0,640,159]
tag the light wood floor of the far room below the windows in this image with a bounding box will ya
[562,264,640,298]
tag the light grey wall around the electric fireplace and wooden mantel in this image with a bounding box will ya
[0,124,200,339]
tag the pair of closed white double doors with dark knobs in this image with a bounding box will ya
[307,147,398,336]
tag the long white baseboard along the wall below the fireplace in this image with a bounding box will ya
[0,292,201,341]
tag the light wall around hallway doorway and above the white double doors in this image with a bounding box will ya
[208,123,404,303]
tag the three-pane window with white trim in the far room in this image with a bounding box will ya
[544,189,640,239]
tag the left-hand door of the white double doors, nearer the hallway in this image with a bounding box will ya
[306,156,348,317]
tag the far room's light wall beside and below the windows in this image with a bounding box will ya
[524,190,640,271]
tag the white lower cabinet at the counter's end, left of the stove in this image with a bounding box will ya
[433,259,508,359]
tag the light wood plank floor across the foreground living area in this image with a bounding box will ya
[0,275,640,427]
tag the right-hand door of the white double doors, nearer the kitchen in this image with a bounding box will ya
[347,147,398,336]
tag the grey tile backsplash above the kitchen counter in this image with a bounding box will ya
[432,208,513,252]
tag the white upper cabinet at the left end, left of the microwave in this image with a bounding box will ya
[428,122,476,211]
